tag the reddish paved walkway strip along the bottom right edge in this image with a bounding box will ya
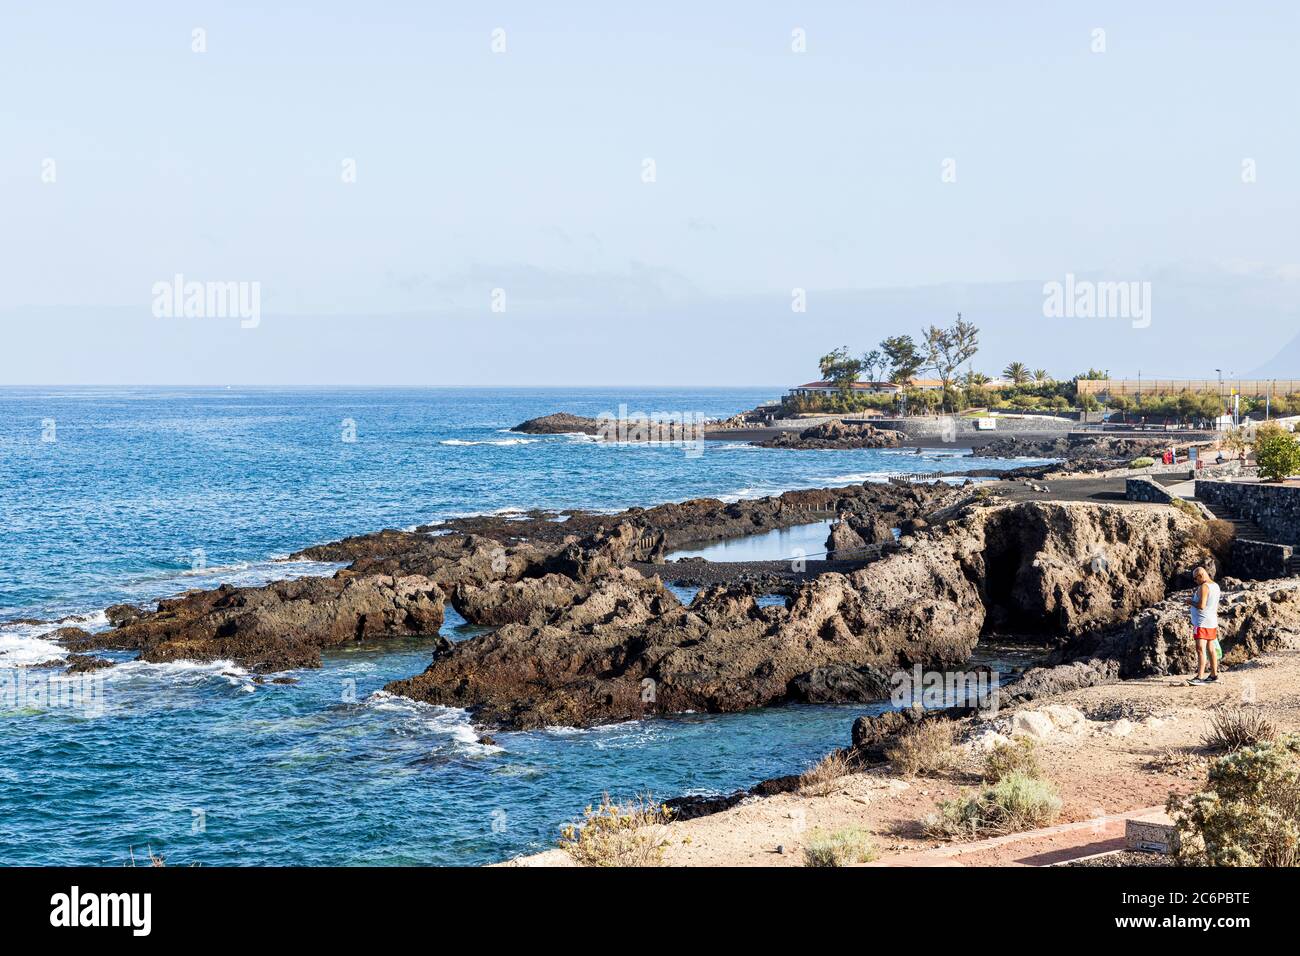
[865,806,1170,866]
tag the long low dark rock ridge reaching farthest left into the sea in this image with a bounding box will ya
[45,485,950,672]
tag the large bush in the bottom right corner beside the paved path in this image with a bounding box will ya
[1169,734,1300,866]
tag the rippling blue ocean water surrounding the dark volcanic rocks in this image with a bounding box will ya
[0,388,1034,865]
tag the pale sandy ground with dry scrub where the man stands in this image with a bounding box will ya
[504,650,1300,866]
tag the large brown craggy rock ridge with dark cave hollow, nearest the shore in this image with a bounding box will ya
[389,497,1214,728]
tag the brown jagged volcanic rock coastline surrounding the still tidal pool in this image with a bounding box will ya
[25,411,1300,858]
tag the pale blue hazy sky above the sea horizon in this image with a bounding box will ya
[0,0,1300,386]
